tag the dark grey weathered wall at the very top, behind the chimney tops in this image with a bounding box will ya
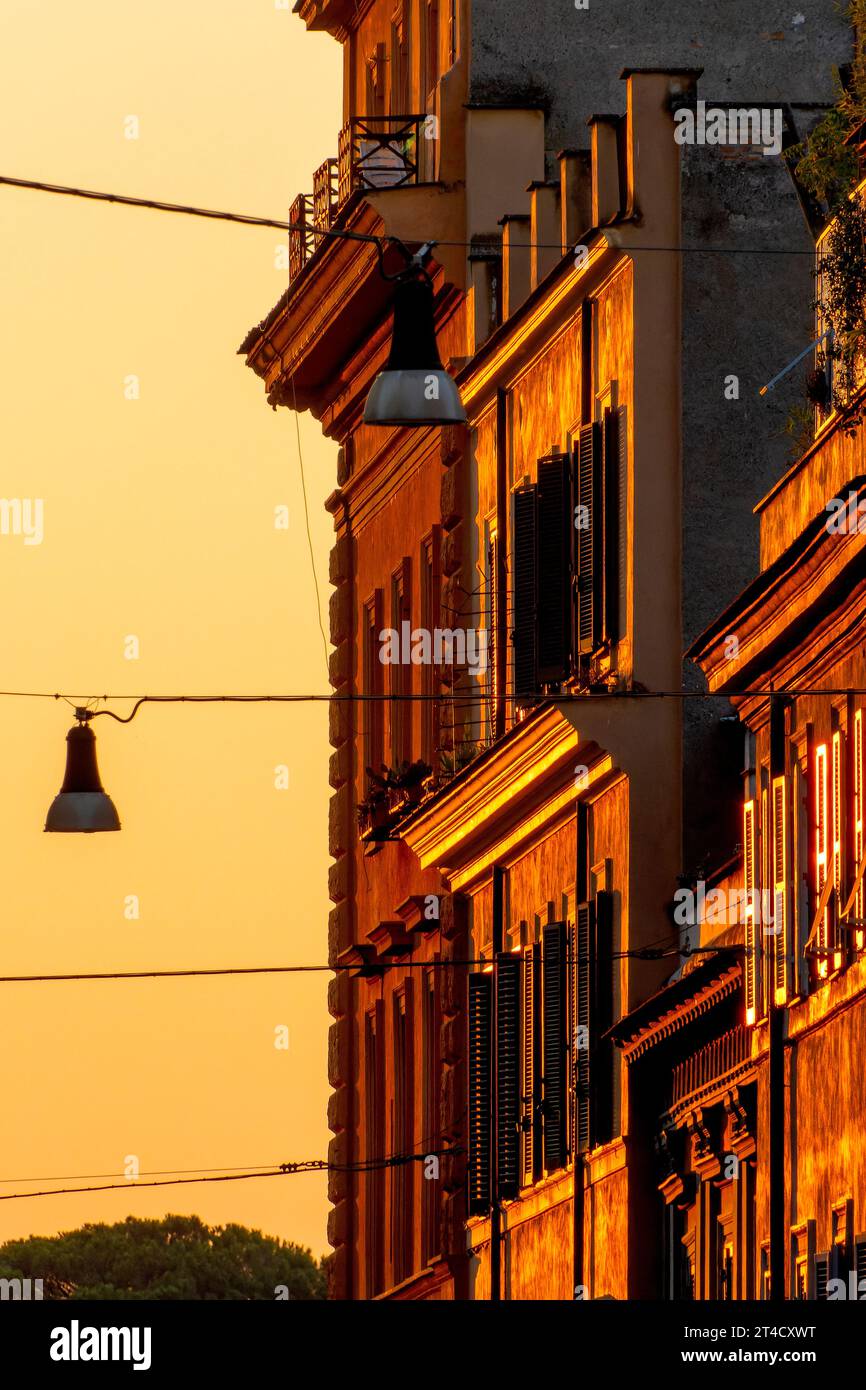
[470,0,851,153]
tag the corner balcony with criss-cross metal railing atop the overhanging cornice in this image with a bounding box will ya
[289,115,432,281]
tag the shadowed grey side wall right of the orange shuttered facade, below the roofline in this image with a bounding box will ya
[681,135,815,870]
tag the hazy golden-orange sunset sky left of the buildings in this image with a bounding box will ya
[0,0,341,1254]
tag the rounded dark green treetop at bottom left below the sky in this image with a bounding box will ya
[0,1216,327,1301]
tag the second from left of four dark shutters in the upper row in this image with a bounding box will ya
[537,453,571,682]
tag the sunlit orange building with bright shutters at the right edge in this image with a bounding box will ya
[683,185,866,1298]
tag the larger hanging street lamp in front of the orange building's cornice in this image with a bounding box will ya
[364,277,466,425]
